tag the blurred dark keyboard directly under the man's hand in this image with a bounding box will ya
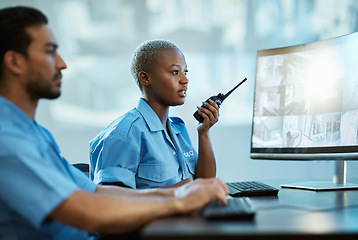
[203,196,255,220]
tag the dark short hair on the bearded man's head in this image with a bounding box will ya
[0,6,48,79]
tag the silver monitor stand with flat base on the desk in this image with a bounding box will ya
[281,160,358,191]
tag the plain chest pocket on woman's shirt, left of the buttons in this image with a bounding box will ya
[138,164,178,182]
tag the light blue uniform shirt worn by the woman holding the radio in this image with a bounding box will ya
[90,98,198,189]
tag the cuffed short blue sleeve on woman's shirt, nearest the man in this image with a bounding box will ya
[90,112,141,188]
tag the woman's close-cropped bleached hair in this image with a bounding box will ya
[130,40,178,92]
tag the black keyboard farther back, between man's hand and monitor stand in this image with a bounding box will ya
[226,181,279,197]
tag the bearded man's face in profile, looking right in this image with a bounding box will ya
[24,24,66,100]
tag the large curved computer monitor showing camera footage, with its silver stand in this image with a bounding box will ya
[250,33,358,190]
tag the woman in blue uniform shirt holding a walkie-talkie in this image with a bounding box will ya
[90,40,219,189]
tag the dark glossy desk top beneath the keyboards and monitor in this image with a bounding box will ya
[141,182,358,240]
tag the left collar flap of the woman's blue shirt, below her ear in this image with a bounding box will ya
[137,98,164,132]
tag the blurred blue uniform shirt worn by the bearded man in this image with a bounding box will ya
[0,96,96,240]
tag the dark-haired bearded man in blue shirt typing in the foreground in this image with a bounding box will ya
[0,7,228,239]
